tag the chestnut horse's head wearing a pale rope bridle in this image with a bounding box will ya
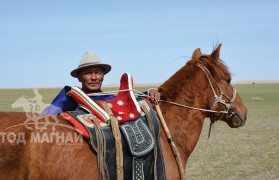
[192,44,247,128]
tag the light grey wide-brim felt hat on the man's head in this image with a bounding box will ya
[71,52,111,78]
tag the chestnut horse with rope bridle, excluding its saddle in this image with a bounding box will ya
[0,45,247,179]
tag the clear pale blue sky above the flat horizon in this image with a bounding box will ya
[0,0,279,88]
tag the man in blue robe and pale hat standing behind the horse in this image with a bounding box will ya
[42,52,160,115]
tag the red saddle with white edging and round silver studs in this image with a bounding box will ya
[61,73,150,137]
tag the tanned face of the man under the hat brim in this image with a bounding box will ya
[78,67,104,93]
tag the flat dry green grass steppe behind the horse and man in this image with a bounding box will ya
[0,84,279,180]
